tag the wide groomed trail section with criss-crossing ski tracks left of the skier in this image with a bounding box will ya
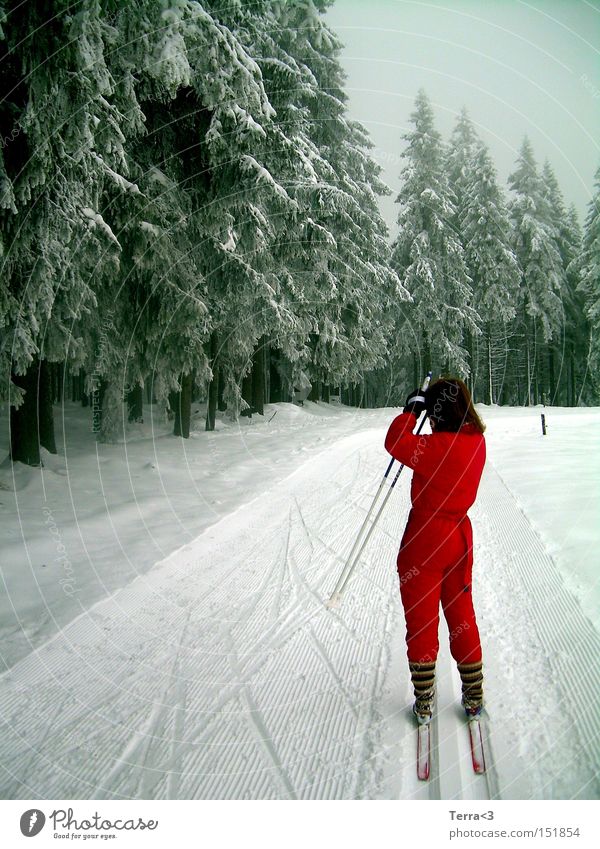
[0,433,408,799]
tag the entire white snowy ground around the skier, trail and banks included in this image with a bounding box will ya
[0,405,600,799]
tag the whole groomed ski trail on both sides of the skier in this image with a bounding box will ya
[0,429,600,799]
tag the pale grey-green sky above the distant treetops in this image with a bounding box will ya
[326,0,600,237]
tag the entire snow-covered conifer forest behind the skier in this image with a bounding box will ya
[0,0,600,466]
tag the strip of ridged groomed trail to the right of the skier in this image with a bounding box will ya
[472,460,600,798]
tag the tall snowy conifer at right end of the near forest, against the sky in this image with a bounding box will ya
[266,0,408,400]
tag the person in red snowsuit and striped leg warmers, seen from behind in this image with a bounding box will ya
[385,377,486,724]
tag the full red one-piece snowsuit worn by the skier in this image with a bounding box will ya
[385,413,485,663]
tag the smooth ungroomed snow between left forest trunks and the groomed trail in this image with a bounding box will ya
[0,402,380,665]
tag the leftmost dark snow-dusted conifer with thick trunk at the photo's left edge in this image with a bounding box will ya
[0,0,141,464]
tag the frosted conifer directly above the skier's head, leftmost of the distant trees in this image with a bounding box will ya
[392,89,479,380]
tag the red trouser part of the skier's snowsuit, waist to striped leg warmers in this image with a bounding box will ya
[398,522,481,663]
